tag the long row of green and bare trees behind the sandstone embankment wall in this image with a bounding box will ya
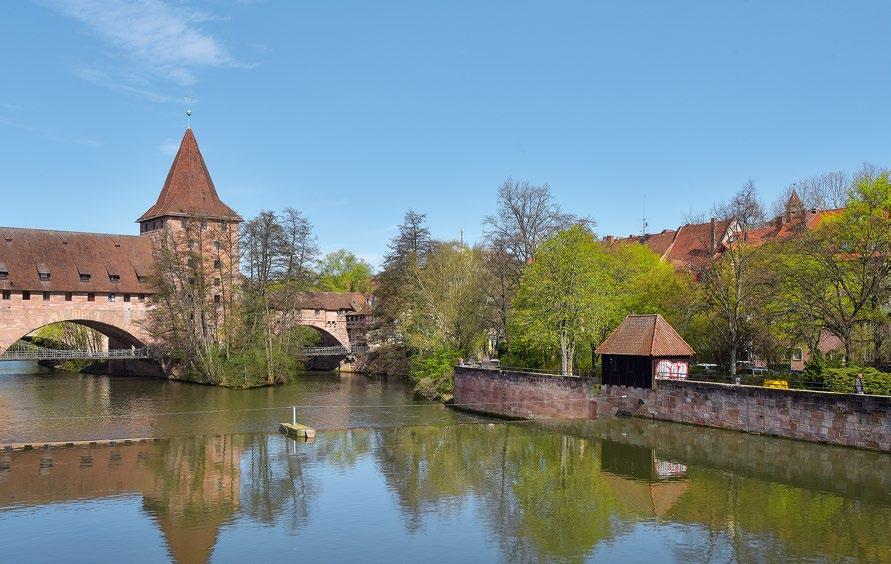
[368,168,891,398]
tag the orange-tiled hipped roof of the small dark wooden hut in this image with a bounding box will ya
[597,314,694,357]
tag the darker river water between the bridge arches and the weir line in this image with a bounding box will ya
[0,363,482,443]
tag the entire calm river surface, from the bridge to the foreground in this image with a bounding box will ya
[0,363,891,562]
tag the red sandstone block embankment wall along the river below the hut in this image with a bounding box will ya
[455,367,891,451]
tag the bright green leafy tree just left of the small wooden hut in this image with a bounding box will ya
[514,225,614,374]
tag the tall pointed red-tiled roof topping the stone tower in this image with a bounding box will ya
[136,128,242,223]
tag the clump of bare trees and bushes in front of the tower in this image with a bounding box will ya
[148,208,371,387]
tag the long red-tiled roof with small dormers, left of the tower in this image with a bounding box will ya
[0,227,153,293]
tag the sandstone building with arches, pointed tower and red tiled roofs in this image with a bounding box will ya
[0,129,369,354]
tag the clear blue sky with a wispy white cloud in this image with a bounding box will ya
[0,0,891,268]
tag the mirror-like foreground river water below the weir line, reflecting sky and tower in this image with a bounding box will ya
[0,420,891,562]
